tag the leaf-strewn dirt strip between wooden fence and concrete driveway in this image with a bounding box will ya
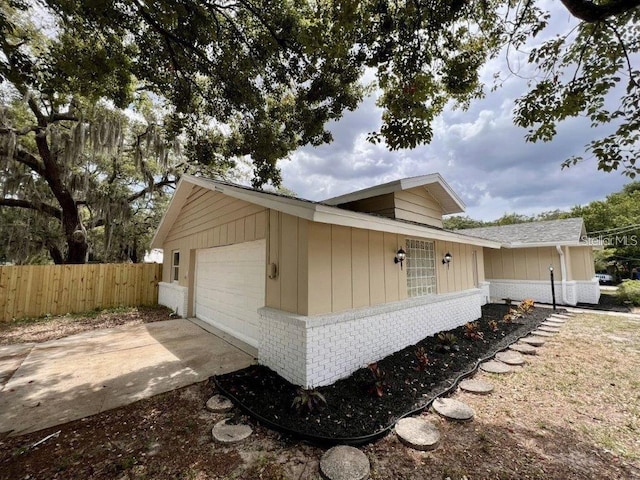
[0,307,171,345]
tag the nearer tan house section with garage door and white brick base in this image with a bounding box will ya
[152,174,500,387]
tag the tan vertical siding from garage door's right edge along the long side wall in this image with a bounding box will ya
[266,210,484,315]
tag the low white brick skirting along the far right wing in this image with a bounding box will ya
[488,280,600,305]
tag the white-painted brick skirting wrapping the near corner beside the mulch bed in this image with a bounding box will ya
[258,288,485,387]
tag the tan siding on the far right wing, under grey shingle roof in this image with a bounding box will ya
[484,247,595,281]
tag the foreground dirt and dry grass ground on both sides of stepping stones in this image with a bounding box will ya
[0,314,640,480]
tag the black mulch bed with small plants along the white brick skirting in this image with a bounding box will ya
[215,304,551,439]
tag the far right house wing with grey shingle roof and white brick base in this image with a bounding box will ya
[458,218,600,305]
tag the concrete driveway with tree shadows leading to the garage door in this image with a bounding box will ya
[0,319,255,438]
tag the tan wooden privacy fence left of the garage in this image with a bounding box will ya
[0,263,162,321]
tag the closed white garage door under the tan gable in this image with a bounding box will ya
[195,240,266,348]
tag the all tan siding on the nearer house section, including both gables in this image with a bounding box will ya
[163,187,484,315]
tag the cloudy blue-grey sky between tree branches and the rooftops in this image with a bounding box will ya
[280,2,630,220]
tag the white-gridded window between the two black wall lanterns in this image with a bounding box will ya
[406,238,437,298]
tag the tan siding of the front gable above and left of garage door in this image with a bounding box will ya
[162,187,267,286]
